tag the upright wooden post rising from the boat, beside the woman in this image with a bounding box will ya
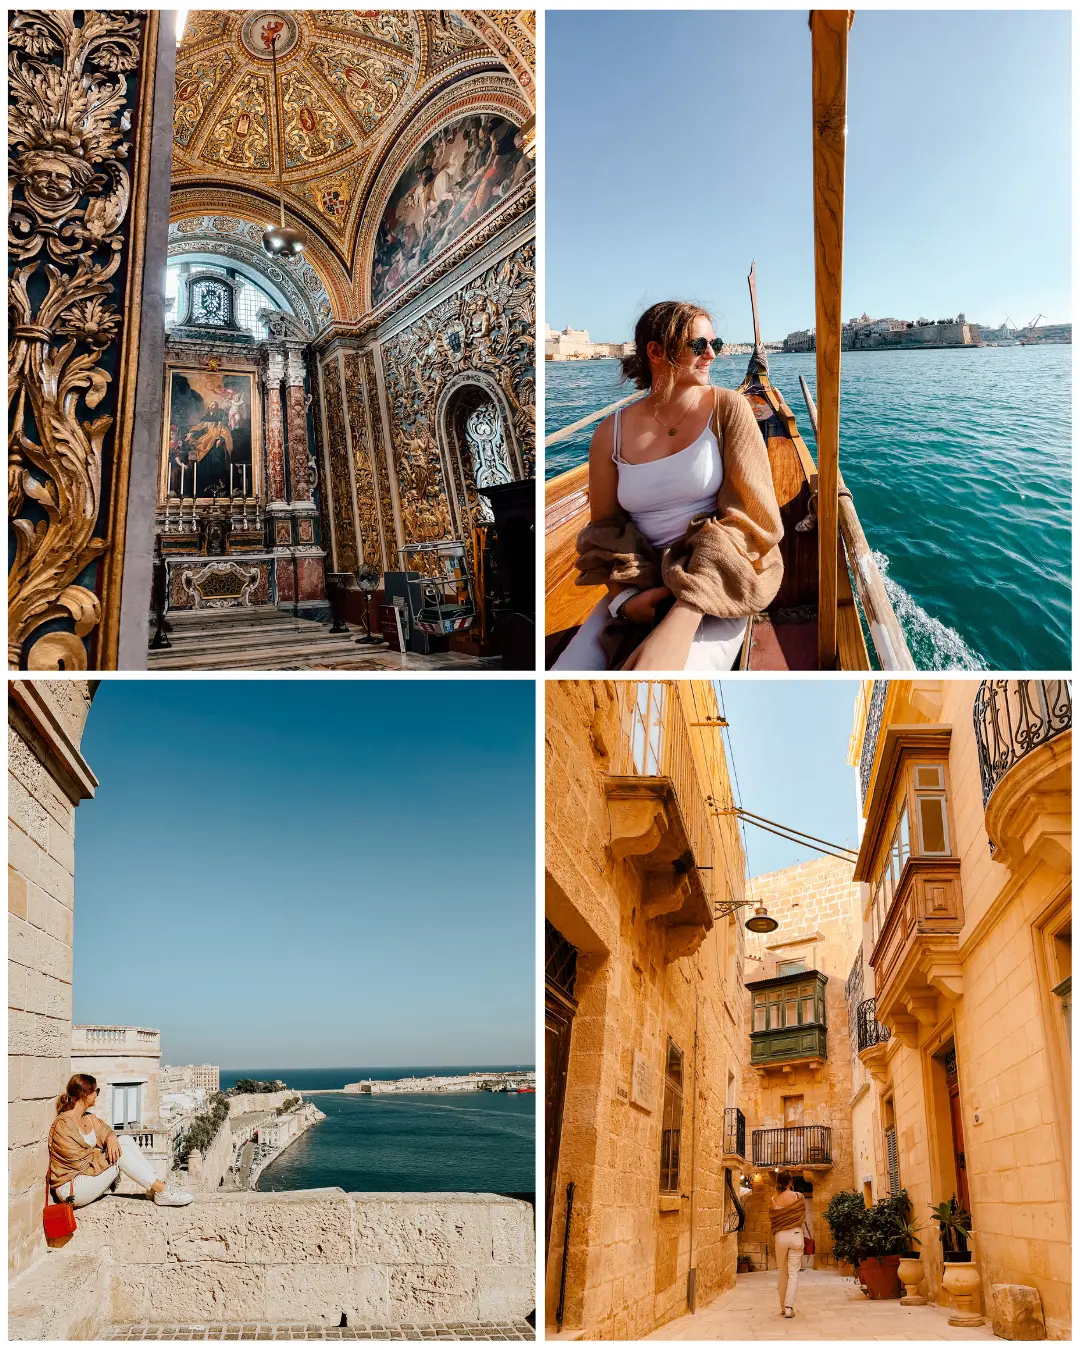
[810,9,855,670]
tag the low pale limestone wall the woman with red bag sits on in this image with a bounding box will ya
[74,1187,535,1327]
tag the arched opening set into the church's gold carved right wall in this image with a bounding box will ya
[435,370,525,541]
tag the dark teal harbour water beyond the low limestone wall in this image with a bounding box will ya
[221,1065,536,1193]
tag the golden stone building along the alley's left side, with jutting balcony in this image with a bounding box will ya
[545,680,749,1339]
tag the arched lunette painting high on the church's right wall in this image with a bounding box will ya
[371,115,529,305]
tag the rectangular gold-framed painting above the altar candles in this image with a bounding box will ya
[161,367,259,500]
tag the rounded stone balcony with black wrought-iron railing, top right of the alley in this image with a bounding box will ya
[973,679,1072,873]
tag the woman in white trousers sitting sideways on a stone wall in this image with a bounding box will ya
[49,1073,194,1210]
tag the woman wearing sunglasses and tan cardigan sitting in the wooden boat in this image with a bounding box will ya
[554,300,783,671]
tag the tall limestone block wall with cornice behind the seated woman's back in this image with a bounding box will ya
[8,680,97,1274]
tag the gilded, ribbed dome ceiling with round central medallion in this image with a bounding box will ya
[173,9,535,317]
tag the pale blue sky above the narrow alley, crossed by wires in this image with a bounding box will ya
[720,679,859,876]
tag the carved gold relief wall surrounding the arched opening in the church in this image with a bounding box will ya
[383,240,536,561]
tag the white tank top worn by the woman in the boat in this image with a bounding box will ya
[612,408,724,548]
